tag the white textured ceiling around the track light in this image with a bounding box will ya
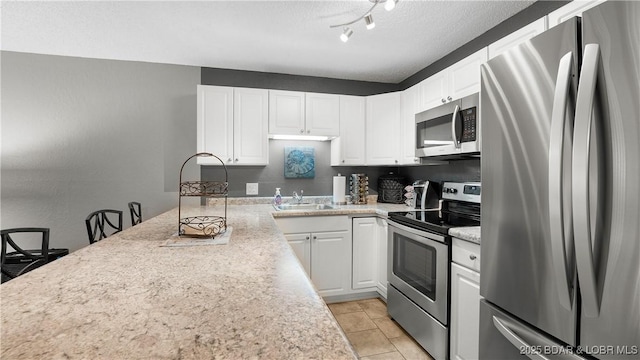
[1,0,533,83]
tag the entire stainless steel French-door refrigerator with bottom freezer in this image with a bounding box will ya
[480,1,640,360]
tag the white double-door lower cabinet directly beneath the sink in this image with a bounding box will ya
[276,216,351,297]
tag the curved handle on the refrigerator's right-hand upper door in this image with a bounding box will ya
[571,44,600,317]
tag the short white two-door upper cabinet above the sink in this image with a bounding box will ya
[269,90,340,136]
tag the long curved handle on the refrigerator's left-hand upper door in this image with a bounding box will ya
[549,52,573,310]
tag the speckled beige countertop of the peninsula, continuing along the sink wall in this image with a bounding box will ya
[0,205,402,359]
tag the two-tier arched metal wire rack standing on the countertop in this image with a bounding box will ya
[178,152,229,238]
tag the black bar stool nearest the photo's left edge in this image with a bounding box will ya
[0,228,49,283]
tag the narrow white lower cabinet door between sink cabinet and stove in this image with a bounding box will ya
[351,217,387,299]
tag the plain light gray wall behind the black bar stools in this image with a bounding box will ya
[0,52,200,251]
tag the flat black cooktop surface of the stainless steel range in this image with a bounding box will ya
[389,210,480,235]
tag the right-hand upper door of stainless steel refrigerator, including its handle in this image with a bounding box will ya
[576,1,640,359]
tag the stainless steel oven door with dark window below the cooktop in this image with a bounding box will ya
[388,221,449,325]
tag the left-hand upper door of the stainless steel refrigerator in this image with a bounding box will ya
[480,18,580,344]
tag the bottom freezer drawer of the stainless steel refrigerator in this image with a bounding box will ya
[479,300,583,360]
